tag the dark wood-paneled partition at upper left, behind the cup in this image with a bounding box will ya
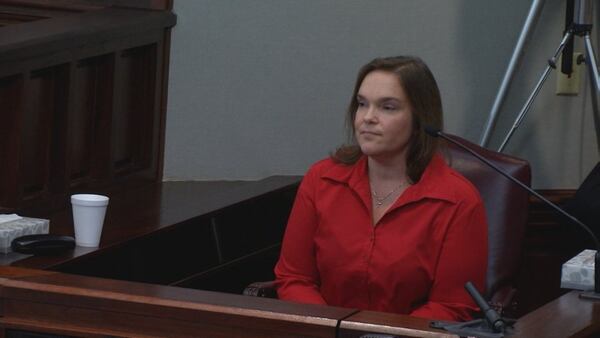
[0,0,175,211]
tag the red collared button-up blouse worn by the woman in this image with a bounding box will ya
[275,155,487,320]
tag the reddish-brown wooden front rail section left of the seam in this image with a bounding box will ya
[0,267,356,338]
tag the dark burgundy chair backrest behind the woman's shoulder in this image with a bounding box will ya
[445,135,531,300]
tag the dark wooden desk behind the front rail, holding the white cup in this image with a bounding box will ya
[3,176,300,294]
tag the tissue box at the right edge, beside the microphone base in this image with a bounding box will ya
[560,250,596,291]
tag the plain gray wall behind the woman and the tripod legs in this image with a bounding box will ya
[164,0,598,188]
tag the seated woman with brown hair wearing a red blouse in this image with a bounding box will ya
[275,57,487,320]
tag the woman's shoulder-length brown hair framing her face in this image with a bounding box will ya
[331,56,443,183]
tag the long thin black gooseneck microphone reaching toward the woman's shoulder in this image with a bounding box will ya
[425,126,600,300]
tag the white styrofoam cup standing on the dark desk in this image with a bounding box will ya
[71,194,108,247]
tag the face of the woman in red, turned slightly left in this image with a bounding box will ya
[354,70,413,159]
